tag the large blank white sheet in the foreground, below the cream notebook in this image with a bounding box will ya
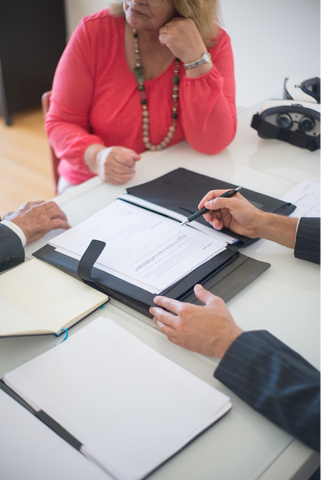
[4,317,231,480]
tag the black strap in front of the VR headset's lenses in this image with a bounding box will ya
[251,113,321,152]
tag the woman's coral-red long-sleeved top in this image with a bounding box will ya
[45,9,236,184]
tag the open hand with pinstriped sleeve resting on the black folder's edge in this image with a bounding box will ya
[149,285,242,358]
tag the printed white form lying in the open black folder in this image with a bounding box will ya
[50,200,226,293]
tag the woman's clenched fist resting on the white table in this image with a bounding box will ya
[84,145,140,185]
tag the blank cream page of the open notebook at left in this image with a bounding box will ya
[0,258,108,336]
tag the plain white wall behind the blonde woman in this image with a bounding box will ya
[65,0,321,107]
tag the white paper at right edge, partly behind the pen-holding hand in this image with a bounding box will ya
[282,180,321,218]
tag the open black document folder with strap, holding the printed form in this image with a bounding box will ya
[34,168,295,316]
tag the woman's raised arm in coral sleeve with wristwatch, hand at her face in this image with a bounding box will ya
[160,18,237,155]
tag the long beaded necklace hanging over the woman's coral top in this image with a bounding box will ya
[133,28,179,151]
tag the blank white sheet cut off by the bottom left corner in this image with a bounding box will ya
[0,390,112,480]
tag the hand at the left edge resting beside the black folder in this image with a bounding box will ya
[3,201,70,243]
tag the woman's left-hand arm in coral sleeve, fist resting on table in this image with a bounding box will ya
[45,20,140,185]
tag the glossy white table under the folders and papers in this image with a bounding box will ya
[0,109,321,480]
